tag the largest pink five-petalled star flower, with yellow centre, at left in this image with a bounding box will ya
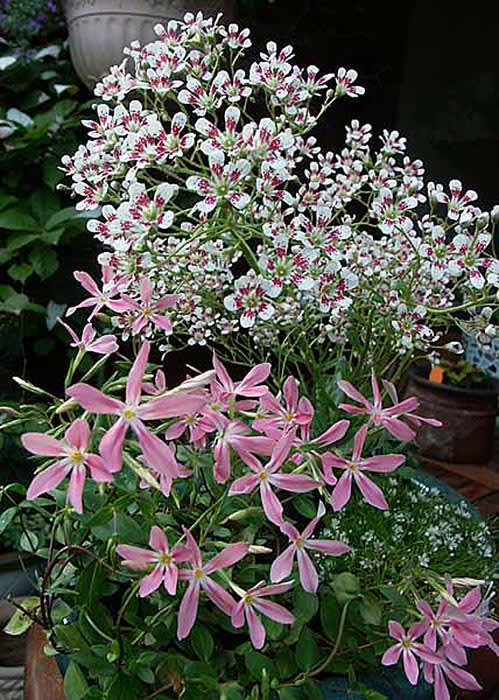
[66,341,206,483]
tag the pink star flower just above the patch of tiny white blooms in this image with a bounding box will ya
[322,425,405,510]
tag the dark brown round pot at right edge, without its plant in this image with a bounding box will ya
[405,370,497,464]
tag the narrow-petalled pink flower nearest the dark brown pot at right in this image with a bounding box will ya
[338,373,442,442]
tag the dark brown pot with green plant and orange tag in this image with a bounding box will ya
[407,356,498,464]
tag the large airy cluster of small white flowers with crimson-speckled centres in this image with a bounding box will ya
[64,9,499,382]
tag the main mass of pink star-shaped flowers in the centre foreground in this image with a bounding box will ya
[22,339,424,648]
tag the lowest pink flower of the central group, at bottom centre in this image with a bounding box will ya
[231,582,295,649]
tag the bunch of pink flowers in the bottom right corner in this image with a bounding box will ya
[382,583,499,700]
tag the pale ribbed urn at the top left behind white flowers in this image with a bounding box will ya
[63,0,233,88]
